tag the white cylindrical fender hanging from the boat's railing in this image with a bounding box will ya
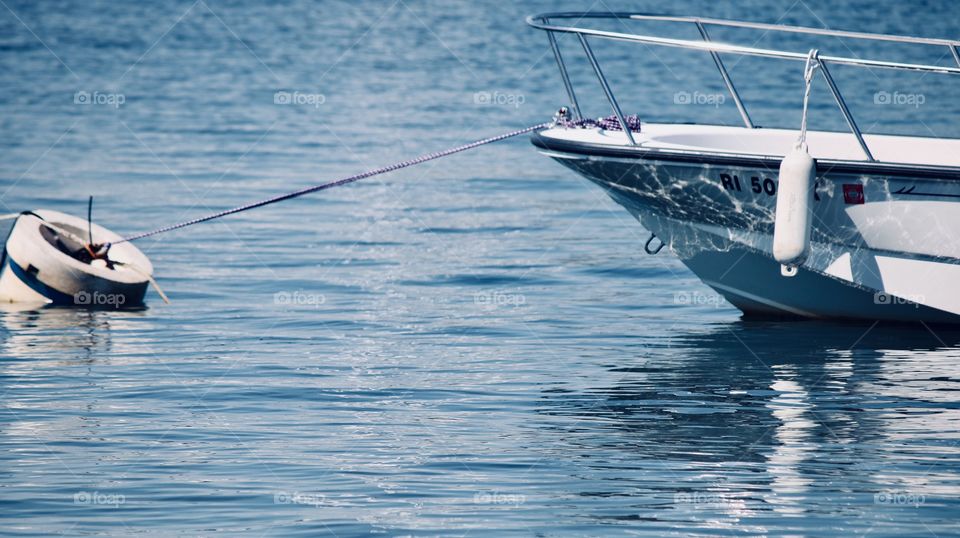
[773,146,817,276]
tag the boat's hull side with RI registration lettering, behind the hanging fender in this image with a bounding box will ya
[534,131,960,323]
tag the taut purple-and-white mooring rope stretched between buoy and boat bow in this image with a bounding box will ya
[113,123,551,244]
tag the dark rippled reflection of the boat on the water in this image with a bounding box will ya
[540,322,960,534]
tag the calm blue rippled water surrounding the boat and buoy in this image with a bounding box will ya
[0,0,960,536]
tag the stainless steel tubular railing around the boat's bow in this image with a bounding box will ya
[527,13,960,161]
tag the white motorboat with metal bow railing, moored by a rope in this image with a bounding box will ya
[528,13,960,323]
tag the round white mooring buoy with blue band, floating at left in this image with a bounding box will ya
[0,209,153,308]
